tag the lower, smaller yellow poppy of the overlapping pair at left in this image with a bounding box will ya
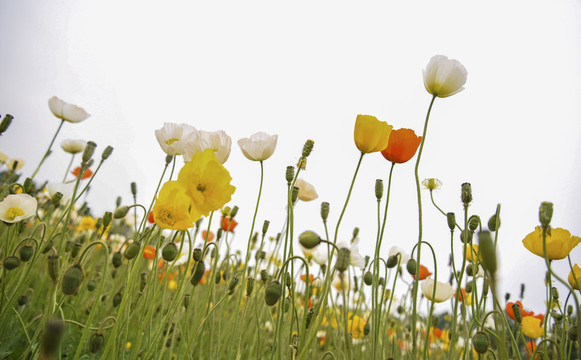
[152,181,200,230]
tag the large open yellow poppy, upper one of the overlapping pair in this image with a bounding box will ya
[176,149,236,221]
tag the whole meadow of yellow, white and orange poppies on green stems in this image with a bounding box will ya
[0,55,581,360]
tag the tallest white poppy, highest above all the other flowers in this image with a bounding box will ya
[424,55,468,98]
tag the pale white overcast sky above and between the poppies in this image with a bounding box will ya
[0,0,581,312]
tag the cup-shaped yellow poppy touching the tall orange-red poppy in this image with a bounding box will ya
[355,115,393,154]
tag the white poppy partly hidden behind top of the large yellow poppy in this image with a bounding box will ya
[184,130,232,164]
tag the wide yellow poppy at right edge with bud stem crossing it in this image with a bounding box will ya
[523,226,581,260]
